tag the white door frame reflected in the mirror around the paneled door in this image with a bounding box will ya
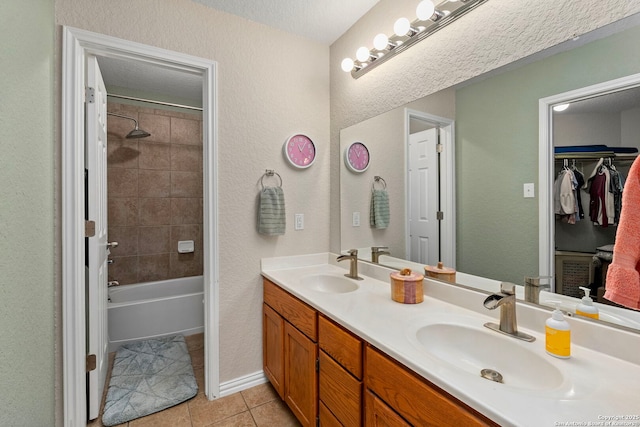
[404,108,456,268]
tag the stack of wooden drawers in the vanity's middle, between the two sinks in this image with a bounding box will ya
[318,315,362,427]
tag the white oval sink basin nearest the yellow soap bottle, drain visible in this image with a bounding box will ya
[415,320,564,390]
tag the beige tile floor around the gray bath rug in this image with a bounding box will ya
[87,334,300,427]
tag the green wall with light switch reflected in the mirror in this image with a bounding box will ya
[456,29,640,284]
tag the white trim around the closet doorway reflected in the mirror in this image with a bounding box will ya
[538,73,640,292]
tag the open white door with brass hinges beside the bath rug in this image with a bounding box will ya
[85,56,109,420]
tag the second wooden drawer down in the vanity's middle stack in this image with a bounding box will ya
[319,351,362,427]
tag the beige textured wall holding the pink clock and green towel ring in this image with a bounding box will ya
[56,0,329,396]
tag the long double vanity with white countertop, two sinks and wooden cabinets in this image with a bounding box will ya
[262,253,640,427]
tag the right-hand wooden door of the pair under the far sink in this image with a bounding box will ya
[284,322,318,427]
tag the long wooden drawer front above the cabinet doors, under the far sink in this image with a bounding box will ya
[264,279,318,342]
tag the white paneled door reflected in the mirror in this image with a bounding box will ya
[407,128,440,265]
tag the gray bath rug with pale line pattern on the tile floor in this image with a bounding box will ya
[102,335,198,426]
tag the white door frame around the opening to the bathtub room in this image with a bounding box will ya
[61,26,220,426]
